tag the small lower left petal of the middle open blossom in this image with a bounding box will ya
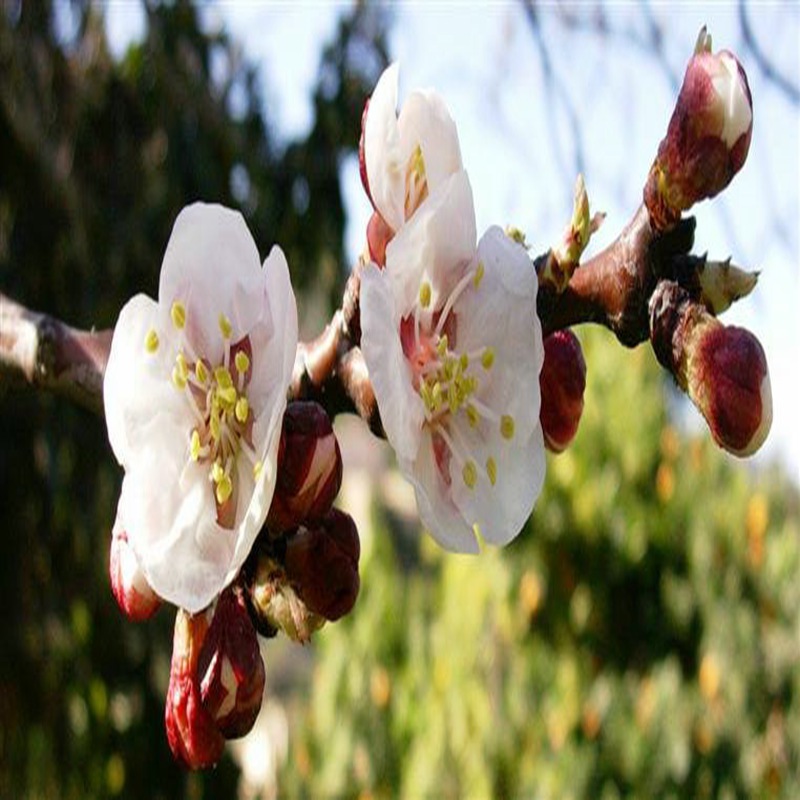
[399,428,478,553]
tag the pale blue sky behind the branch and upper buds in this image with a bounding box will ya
[106,2,800,479]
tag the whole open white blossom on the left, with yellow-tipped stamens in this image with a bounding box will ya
[104,203,297,612]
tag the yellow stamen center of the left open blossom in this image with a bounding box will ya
[145,300,262,526]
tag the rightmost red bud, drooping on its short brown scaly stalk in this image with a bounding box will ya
[650,281,772,456]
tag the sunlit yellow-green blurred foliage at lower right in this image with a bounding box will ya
[283,331,800,800]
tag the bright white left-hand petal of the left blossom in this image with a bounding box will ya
[103,294,193,469]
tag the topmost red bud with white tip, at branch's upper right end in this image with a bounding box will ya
[644,28,753,230]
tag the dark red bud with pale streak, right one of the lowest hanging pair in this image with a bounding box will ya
[197,589,265,739]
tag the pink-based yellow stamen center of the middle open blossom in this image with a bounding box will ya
[400,261,514,496]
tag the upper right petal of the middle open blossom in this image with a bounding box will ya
[455,227,544,440]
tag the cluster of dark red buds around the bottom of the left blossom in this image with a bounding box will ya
[110,402,360,769]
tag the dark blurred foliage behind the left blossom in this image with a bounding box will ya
[0,0,386,798]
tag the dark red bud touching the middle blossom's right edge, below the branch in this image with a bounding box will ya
[539,330,586,453]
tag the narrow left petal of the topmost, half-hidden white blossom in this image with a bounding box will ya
[364,64,406,230]
